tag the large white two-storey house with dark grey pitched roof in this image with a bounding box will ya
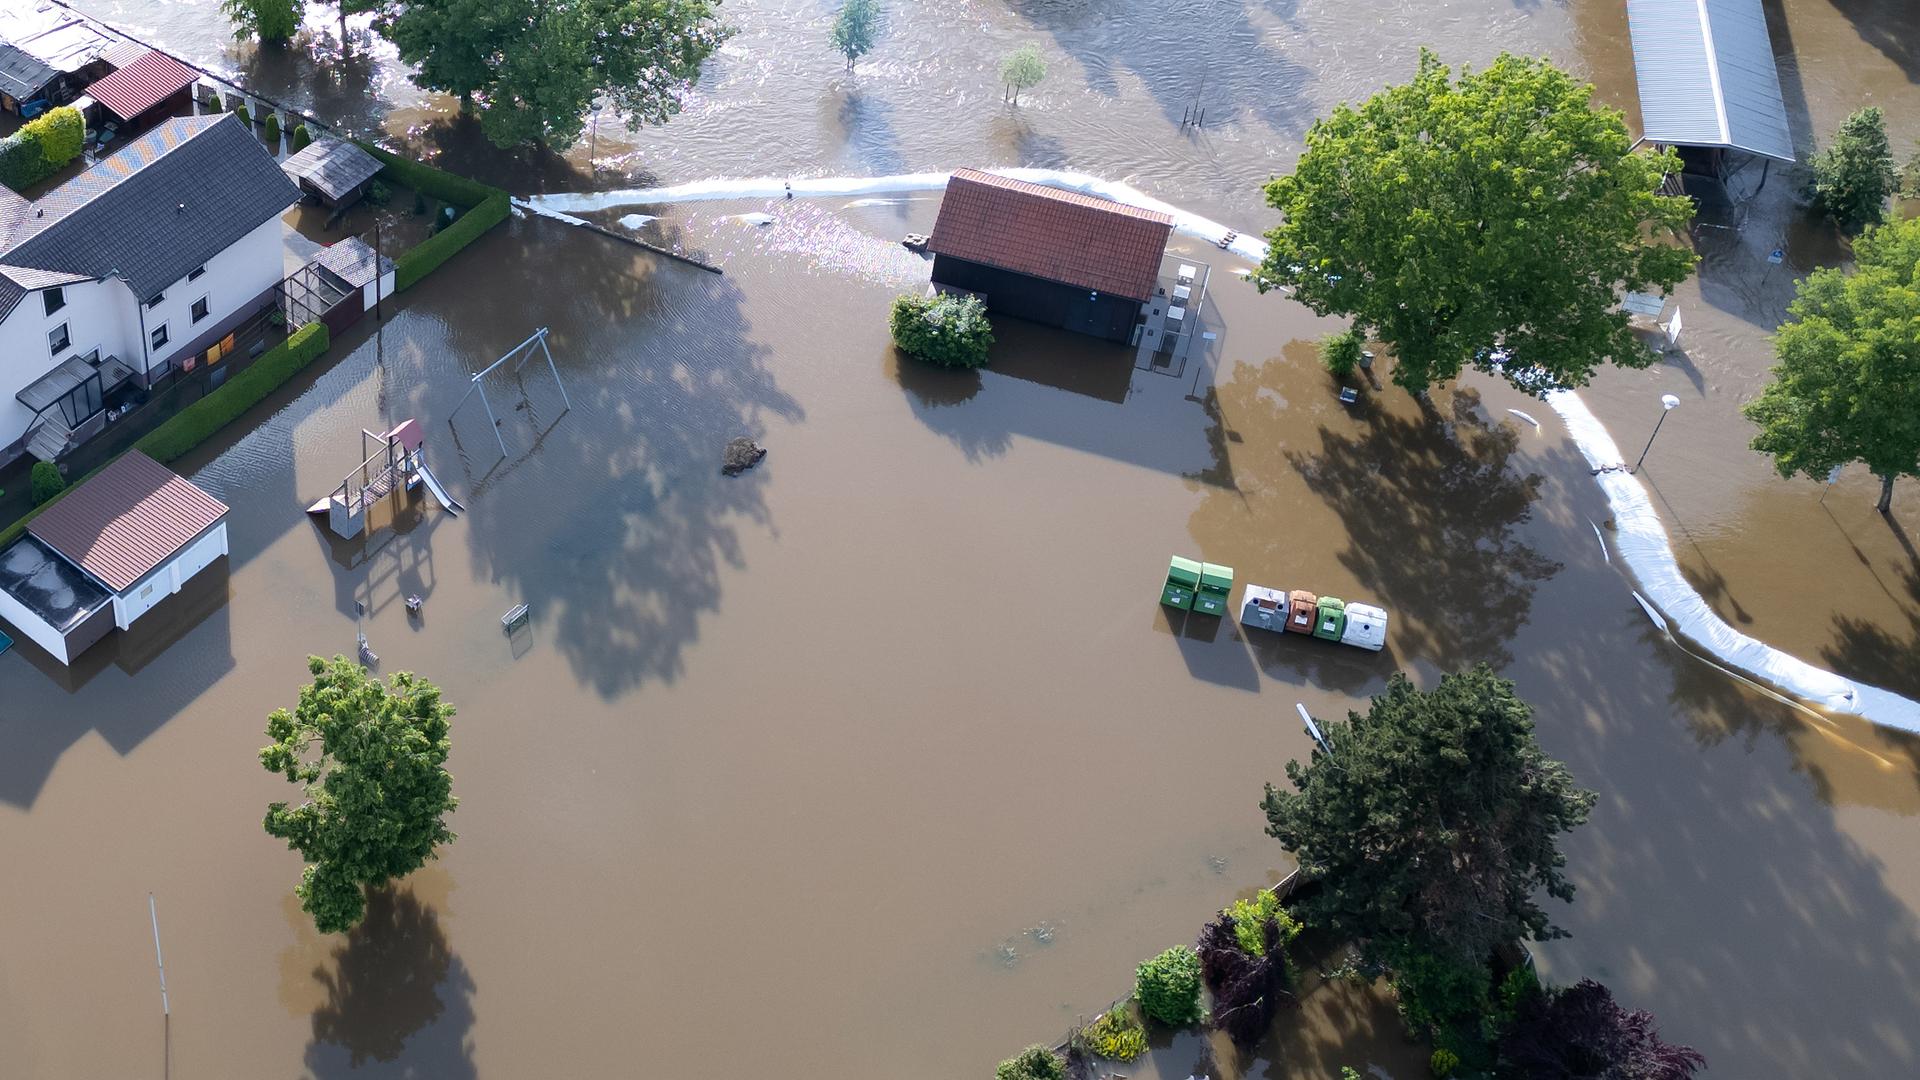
[0,113,300,463]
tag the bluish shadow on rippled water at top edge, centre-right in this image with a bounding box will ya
[1008,0,1320,138]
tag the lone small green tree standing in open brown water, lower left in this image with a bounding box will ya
[259,657,459,934]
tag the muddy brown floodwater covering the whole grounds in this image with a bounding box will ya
[0,0,1920,1080]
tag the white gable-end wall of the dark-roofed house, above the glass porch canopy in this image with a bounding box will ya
[0,281,140,448]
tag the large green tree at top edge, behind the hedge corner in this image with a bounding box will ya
[374,0,732,146]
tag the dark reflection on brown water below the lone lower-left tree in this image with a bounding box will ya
[305,884,478,1080]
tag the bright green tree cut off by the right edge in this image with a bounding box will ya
[1741,219,1920,513]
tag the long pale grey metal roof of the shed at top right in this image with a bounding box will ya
[1626,0,1793,161]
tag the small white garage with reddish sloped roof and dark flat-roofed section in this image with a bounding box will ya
[0,450,227,663]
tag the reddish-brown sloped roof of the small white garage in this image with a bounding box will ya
[27,450,227,592]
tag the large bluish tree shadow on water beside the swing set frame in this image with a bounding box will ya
[439,221,804,698]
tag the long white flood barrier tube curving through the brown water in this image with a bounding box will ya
[518,169,1920,732]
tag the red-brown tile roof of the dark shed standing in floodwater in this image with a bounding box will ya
[927,169,1173,300]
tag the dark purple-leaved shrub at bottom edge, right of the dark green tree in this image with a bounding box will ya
[1498,978,1707,1080]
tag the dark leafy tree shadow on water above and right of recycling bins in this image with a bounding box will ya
[1277,382,1561,671]
